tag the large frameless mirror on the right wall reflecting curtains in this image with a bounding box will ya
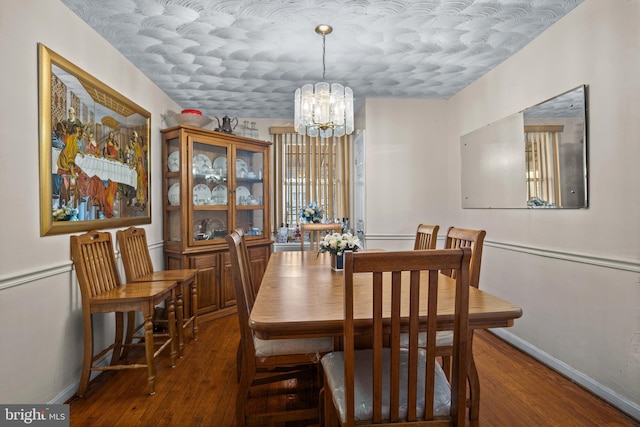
[460,85,588,209]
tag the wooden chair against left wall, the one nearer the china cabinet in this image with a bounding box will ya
[116,227,198,357]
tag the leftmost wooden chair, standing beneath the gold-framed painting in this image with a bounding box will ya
[71,231,178,397]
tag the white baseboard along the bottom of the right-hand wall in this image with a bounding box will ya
[491,329,640,421]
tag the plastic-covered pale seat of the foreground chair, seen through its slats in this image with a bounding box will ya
[321,349,451,422]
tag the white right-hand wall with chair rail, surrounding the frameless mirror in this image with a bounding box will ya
[448,0,640,417]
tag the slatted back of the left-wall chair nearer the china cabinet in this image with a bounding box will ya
[117,227,153,282]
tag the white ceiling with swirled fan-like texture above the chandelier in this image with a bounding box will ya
[62,0,583,118]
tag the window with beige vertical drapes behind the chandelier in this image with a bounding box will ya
[269,127,351,230]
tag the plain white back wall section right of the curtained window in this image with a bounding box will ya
[358,99,448,249]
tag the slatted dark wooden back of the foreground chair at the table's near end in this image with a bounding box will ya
[344,248,471,426]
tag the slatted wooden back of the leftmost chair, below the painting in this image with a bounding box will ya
[71,231,121,303]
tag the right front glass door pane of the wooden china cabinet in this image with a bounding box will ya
[232,149,265,236]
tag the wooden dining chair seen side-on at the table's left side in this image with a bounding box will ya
[226,229,333,426]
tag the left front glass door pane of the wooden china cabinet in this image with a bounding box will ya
[188,137,230,244]
